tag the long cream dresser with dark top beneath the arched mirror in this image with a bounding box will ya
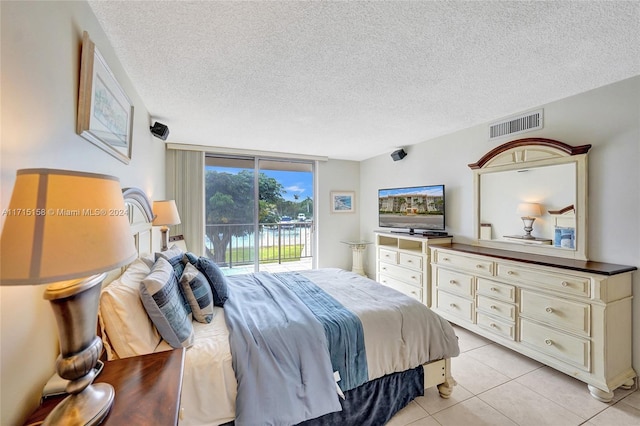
[431,244,637,402]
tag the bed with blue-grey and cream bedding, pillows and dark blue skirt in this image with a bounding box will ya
[99,188,459,426]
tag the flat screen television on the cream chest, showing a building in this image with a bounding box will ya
[378,185,447,235]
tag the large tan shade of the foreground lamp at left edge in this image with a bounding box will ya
[0,169,137,285]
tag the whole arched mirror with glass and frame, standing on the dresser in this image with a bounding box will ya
[469,139,590,260]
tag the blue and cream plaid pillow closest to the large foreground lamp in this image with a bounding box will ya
[140,258,194,348]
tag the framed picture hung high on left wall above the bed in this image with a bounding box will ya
[76,31,133,164]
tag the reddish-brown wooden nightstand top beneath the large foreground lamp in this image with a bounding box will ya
[25,349,184,425]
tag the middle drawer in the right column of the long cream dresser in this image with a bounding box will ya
[520,290,591,336]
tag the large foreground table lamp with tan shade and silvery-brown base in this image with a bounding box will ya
[0,169,137,425]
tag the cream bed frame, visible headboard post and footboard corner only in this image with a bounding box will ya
[110,188,456,422]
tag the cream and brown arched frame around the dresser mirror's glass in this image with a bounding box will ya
[469,138,591,260]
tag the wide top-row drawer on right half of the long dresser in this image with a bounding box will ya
[497,263,591,297]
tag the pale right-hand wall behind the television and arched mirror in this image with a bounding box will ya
[360,76,640,372]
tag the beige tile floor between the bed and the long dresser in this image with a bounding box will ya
[387,326,640,426]
